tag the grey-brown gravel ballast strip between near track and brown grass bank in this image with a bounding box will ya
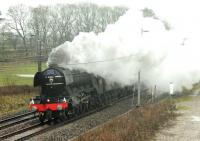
[29,99,131,141]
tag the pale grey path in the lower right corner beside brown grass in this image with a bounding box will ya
[155,95,200,141]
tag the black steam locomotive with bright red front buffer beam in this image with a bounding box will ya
[30,67,132,122]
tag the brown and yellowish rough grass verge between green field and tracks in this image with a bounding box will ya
[0,86,38,116]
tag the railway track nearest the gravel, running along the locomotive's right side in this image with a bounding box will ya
[0,96,134,141]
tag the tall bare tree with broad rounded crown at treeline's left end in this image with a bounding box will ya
[7,5,29,55]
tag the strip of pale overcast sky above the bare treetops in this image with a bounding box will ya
[0,0,132,14]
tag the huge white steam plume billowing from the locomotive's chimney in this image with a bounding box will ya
[48,0,200,90]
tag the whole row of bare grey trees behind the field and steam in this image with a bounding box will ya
[0,3,127,59]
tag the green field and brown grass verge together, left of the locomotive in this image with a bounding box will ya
[0,61,46,116]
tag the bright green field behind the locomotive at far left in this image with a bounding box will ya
[0,62,47,86]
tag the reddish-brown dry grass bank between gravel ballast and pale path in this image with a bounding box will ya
[74,100,176,141]
